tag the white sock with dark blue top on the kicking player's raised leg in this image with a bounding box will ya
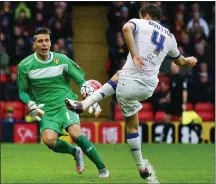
[82,80,117,110]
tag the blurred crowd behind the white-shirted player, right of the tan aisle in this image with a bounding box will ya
[106,1,215,106]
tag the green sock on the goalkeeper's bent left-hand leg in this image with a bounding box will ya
[49,139,76,155]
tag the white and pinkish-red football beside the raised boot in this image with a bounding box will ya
[80,80,102,98]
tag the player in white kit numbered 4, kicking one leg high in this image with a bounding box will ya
[65,4,197,183]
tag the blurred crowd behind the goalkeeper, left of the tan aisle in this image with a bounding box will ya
[0,1,73,98]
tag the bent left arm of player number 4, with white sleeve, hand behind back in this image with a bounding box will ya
[122,21,144,69]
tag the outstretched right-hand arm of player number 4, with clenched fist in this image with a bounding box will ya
[168,35,197,68]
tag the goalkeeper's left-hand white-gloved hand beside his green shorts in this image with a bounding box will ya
[28,101,45,121]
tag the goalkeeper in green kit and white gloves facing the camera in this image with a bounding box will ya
[18,28,109,178]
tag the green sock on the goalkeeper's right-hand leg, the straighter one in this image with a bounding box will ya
[74,135,105,169]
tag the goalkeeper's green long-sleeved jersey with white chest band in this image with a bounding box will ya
[18,52,85,112]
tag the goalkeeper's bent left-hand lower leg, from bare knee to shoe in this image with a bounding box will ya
[42,129,85,174]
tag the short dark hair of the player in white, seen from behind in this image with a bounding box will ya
[139,3,162,21]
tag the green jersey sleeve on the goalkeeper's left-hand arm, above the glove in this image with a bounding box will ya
[17,65,31,104]
